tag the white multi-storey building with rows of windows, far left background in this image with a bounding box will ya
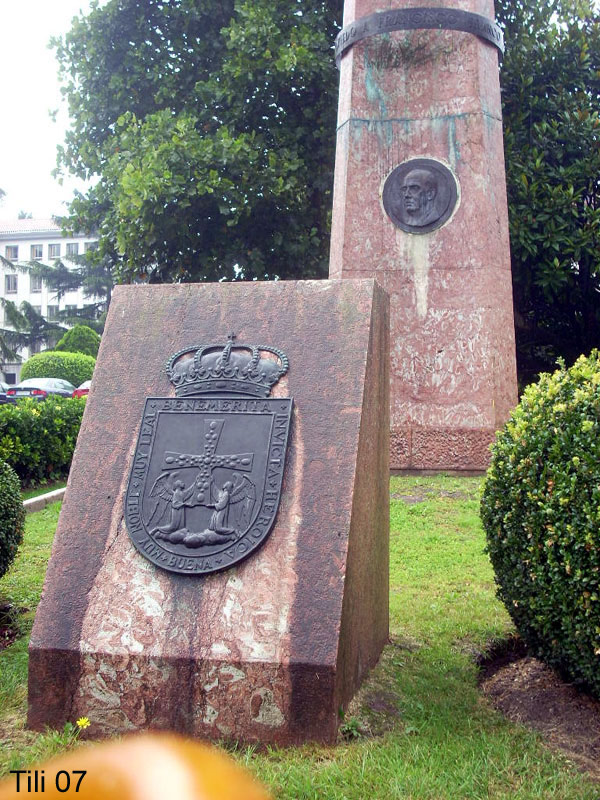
[0,219,96,383]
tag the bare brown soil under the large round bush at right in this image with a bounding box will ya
[481,646,600,781]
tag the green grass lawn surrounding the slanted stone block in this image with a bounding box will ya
[0,477,600,800]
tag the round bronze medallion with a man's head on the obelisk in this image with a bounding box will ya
[383,158,458,233]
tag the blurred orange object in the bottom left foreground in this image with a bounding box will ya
[0,734,272,800]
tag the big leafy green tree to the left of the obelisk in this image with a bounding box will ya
[54,0,342,281]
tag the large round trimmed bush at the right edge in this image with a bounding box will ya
[481,351,600,697]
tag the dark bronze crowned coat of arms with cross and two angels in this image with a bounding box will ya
[125,334,293,575]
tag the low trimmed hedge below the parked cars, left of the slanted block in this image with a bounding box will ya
[0,395,86,484]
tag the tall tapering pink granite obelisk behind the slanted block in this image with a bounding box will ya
[330,0,517,470]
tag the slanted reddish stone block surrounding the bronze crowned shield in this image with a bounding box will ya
[28,280,389,744]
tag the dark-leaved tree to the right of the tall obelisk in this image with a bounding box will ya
[497,0,600,383]
